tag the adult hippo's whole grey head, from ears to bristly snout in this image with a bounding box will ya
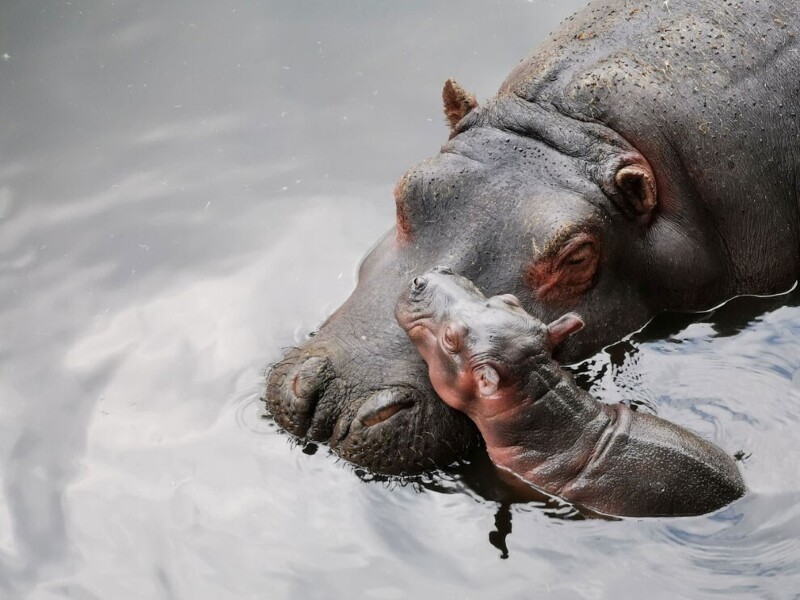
[266,81,724,474]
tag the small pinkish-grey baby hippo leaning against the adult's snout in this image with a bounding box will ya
[396,267,745,517]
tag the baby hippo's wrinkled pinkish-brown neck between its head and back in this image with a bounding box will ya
[476,356,614,494]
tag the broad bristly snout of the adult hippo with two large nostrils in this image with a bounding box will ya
[266,338,478,474]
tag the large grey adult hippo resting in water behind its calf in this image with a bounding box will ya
[266,0,800,473]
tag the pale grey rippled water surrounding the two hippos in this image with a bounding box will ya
[0,0,800,600]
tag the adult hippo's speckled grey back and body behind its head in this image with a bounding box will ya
[499,0,800,296]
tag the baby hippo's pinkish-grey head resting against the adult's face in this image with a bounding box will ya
[395,267,583,416]
